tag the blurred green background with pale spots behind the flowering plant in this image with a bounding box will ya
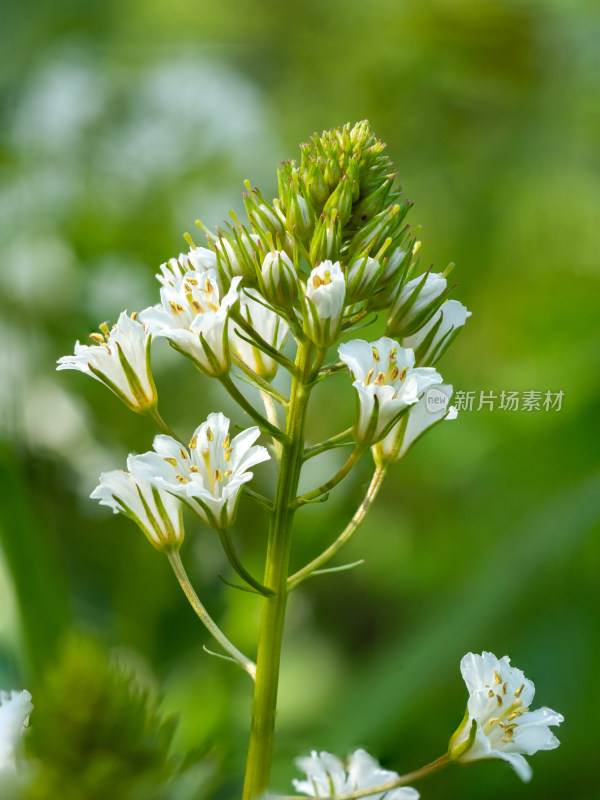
[0,0,600,800]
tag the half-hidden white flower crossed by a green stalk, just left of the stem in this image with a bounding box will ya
[229,289,288,380]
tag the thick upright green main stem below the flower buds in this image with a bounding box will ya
[243,344,313,800]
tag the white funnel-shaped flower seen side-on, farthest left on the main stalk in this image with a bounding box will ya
[57,311,157,411]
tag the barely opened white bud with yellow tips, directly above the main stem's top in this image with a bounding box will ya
[304,261,346,346]
